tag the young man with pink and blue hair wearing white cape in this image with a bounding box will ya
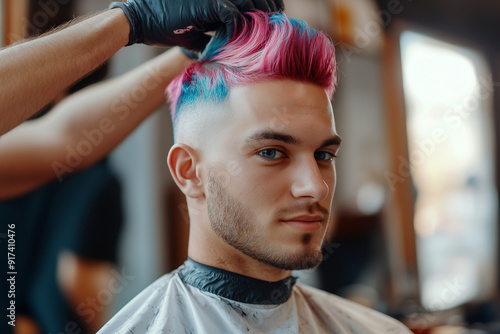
[96,13,410,334]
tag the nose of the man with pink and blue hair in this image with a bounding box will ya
[292,158,329,202]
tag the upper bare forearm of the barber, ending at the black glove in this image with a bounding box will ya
[0,9,130,136]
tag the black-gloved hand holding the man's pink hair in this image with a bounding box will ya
[110,0,284,51]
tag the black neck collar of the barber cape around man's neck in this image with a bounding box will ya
[179,258,297,305]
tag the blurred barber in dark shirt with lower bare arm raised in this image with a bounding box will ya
[0,48,192,333]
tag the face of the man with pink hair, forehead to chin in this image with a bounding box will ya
[205,80,340,270]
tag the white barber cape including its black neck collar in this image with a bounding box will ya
[98,259,411,334]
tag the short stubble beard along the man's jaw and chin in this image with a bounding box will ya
[207,172,328,270]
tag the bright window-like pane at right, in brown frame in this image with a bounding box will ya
[401,31,497,310]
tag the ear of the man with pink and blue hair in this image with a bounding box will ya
[167,144,205,198]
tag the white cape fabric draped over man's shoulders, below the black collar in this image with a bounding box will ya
[98,267,411,334]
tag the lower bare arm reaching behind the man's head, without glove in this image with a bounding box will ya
[0,48,191,199]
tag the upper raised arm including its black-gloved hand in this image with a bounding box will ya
[0,0,283,136]
